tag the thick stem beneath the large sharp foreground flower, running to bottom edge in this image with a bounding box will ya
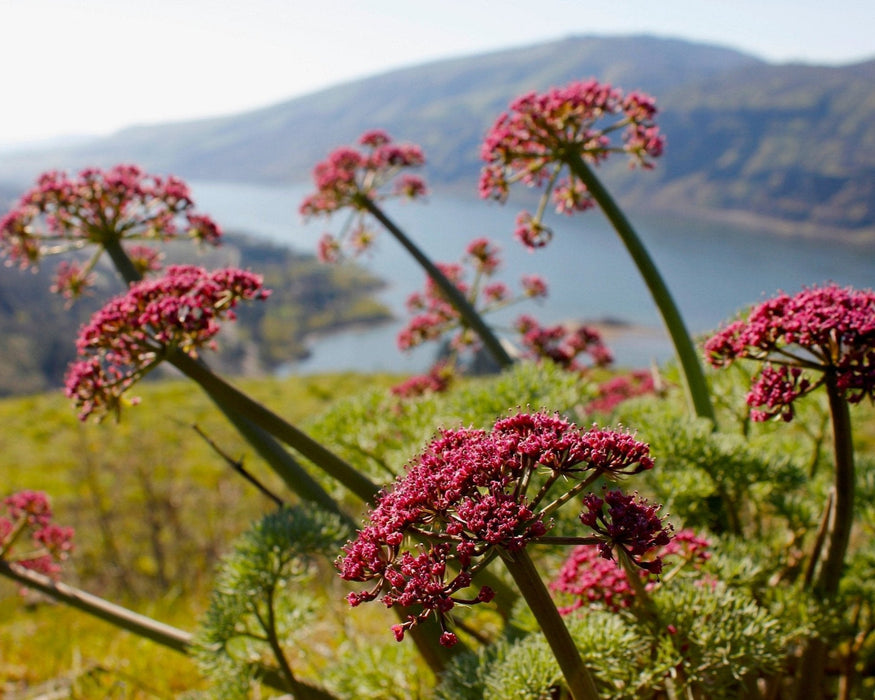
[501,549,599,700]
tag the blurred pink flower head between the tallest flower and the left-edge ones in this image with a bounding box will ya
[300,130,427,262]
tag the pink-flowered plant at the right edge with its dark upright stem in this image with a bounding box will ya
[705,284,875,698]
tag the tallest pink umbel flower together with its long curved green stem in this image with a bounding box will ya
[480,80,715,421]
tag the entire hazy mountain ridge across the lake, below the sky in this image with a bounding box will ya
[0,36,875,239]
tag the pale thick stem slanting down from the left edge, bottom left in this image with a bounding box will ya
[0,559,335,700]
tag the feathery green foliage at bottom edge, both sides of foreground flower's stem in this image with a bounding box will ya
[435,581,801,700]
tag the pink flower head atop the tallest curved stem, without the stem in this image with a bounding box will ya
[480,80,664,248]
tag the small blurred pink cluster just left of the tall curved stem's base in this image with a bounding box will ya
[516,315,614,372]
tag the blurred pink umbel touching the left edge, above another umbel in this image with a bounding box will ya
[0,165,221,297]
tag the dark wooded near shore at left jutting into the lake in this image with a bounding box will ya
[0,234,391,397]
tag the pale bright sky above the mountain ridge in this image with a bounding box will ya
[0,0,875,147]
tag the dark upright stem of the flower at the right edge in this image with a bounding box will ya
[815,375,854,597]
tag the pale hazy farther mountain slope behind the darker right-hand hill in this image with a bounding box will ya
[0,37,758,181]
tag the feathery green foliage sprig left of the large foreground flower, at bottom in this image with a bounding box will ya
[195,504,350,700]
